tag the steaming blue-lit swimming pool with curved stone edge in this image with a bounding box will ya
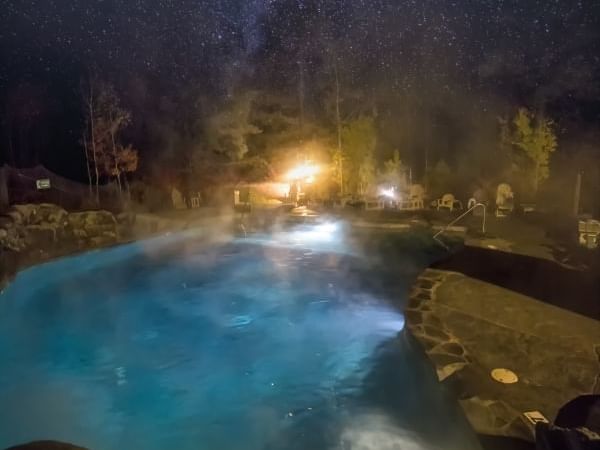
[0,232,478,450]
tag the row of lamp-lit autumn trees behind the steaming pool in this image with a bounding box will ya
[58,66,558,209]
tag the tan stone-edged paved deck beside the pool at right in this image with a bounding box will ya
[405,269,600,441]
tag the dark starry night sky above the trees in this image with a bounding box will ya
[0,0,600,178]
